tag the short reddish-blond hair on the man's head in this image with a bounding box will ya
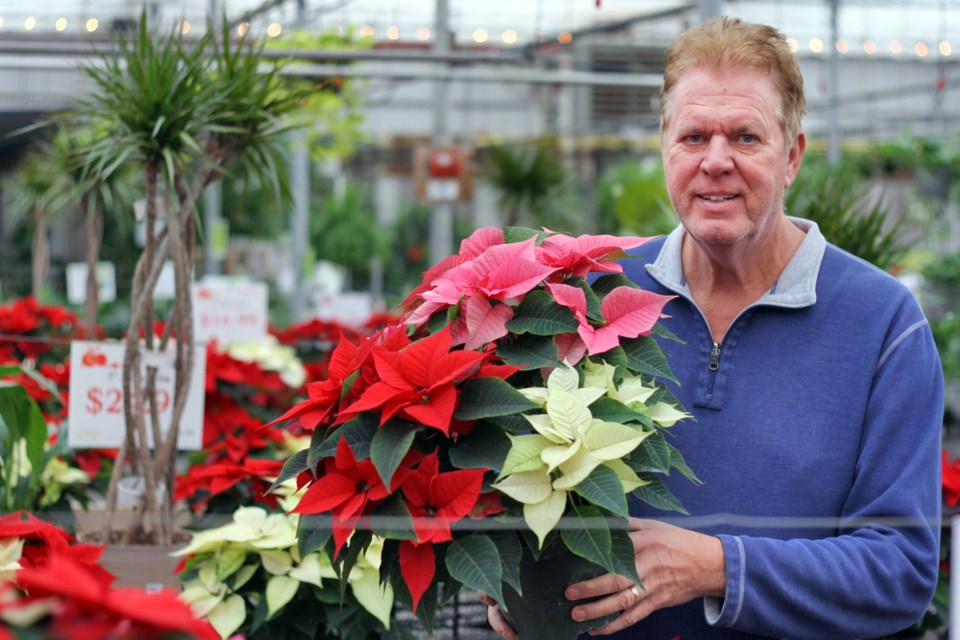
[660,17,807,148]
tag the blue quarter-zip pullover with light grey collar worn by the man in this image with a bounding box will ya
[604,219,943,640]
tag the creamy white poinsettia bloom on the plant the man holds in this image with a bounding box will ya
[494,363,651,544]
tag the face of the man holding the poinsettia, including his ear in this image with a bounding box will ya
[662,67,804,244]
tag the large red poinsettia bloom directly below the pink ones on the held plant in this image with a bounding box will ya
[344,328,487,435]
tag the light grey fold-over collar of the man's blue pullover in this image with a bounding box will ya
[646,216,827,308]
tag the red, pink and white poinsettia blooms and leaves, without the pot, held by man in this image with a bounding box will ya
[275,228,696,629]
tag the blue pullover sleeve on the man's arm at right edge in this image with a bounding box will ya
[704,320,943,640]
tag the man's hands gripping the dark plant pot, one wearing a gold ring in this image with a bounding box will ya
[560,518,727,639]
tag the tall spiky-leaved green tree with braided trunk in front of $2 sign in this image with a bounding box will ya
[76,12,310,544]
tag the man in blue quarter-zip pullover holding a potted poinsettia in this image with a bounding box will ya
[486,18,943,640]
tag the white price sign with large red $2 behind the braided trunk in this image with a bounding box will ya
[67,340,207,450]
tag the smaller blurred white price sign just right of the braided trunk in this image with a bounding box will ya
[193,282,268,344]
